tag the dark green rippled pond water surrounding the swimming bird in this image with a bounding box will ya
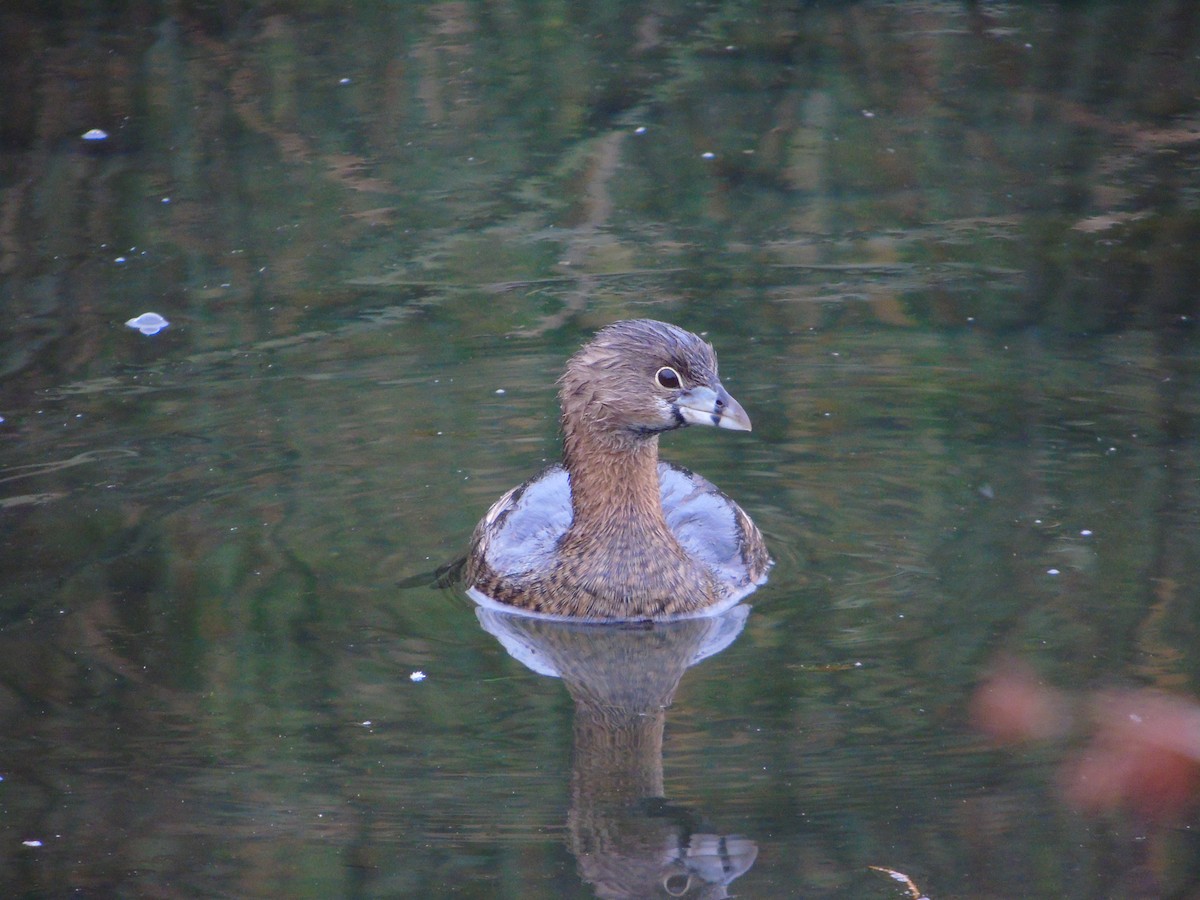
[0,0,1200,900]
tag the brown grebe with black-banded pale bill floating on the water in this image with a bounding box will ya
[466,319,770,619]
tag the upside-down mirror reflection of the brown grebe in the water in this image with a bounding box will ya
[476,606,758,900]
